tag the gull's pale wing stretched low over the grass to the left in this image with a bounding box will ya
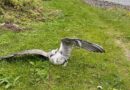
[0,49,48,60]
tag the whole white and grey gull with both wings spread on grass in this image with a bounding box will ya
[0,38,105,65]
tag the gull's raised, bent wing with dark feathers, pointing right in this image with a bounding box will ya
[59,38,105,56]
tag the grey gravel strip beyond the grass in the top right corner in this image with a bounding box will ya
[84,0,130,11]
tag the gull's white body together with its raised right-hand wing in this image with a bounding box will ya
[49,38,105,65]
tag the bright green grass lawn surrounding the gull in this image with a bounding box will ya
[0,0,130,90]
